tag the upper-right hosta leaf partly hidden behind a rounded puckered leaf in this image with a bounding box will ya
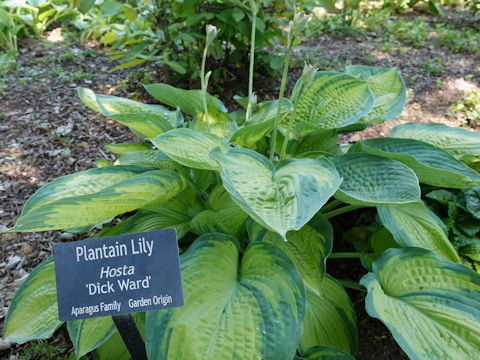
[345,65,407,123]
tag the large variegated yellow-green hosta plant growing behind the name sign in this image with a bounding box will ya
[3,10,480,360]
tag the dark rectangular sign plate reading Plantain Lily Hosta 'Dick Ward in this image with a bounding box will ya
[53,229,183,321]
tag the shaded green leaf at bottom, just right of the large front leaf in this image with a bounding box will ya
[299,274,358,354]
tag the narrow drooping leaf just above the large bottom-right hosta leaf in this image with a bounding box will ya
[377,202,460,263]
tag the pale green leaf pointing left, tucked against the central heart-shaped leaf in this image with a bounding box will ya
[151,128,228,170]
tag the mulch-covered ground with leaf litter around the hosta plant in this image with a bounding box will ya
[0,9,480,360]
